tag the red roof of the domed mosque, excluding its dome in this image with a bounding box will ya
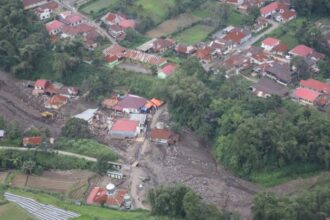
[86,187,128,207]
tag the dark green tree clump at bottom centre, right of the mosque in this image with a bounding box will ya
[148,185,232,220]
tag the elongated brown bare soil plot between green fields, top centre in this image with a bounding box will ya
[147,13,200,38]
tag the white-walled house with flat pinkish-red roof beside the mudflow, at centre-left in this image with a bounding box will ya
[109,118,140,139]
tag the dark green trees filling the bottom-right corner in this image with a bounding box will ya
[252,187,330,220]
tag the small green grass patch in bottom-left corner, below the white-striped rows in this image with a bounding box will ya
[0,203,34,220]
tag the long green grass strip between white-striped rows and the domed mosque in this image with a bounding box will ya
[6,189,179,220]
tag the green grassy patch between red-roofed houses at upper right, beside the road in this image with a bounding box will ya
[262,17,306,49]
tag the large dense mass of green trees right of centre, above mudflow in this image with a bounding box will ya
[163,57,330,181]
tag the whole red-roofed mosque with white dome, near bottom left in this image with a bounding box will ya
[86,183,131,209]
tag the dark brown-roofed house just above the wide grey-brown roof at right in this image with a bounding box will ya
[265,61,295,86]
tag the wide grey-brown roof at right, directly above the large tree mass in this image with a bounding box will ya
[252,77,289,96]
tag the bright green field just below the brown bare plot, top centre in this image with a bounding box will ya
[174,24,214,44]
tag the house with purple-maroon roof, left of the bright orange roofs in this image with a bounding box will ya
[112,94,148,114]
